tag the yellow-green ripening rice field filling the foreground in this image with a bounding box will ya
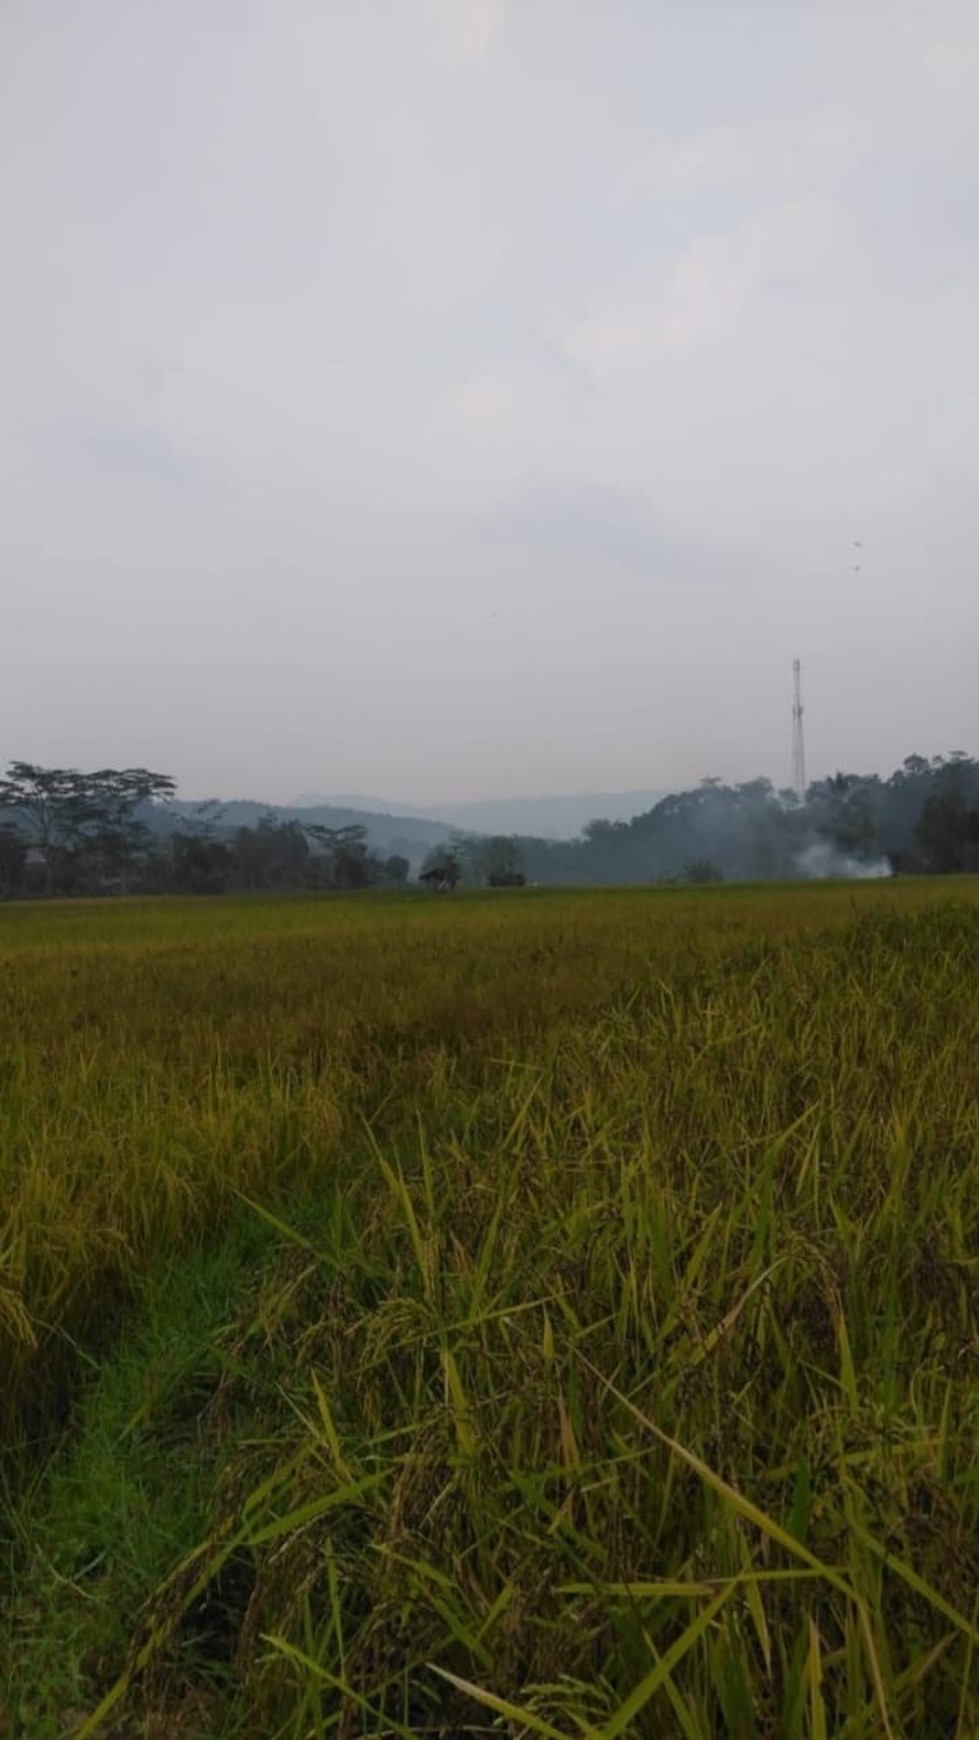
[0,879,979,1740]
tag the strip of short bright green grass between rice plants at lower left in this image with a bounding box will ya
[9,1218,270,1740]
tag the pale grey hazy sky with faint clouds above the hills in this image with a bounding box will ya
[0,0,979,802]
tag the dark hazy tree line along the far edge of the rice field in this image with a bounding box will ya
[0,752,979,898]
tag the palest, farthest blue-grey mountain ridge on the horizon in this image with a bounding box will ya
[296,792,666,840]
